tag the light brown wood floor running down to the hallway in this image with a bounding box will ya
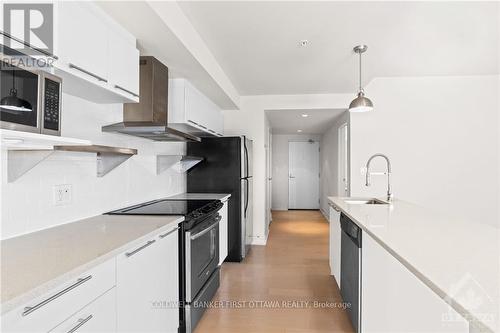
[195,211,354,333]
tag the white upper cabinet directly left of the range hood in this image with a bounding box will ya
[54,1,139,103]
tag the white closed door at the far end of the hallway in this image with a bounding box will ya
[288,141,319,209]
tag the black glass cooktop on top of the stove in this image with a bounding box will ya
[108,199,214,216]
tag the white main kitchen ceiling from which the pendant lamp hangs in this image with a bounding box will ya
[179,1,499,95]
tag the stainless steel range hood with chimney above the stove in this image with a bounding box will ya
[102,56,201,142]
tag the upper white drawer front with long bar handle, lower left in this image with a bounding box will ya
[2,259,116,332]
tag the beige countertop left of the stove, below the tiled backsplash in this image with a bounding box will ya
[0,215,184,314]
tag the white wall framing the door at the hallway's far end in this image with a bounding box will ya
[272,134,321,210]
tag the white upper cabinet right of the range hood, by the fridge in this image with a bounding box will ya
[168,79,224,136]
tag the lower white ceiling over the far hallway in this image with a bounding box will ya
[266,109,347,134]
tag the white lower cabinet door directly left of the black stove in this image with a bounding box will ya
[116,227,179,332]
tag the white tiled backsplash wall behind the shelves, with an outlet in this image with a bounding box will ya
[0,94,185,239]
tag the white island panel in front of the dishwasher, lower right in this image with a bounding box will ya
[361,233,469,333]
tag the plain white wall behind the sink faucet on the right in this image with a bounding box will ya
[351,76,500,225]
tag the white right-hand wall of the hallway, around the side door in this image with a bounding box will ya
[319,112,349,216]
